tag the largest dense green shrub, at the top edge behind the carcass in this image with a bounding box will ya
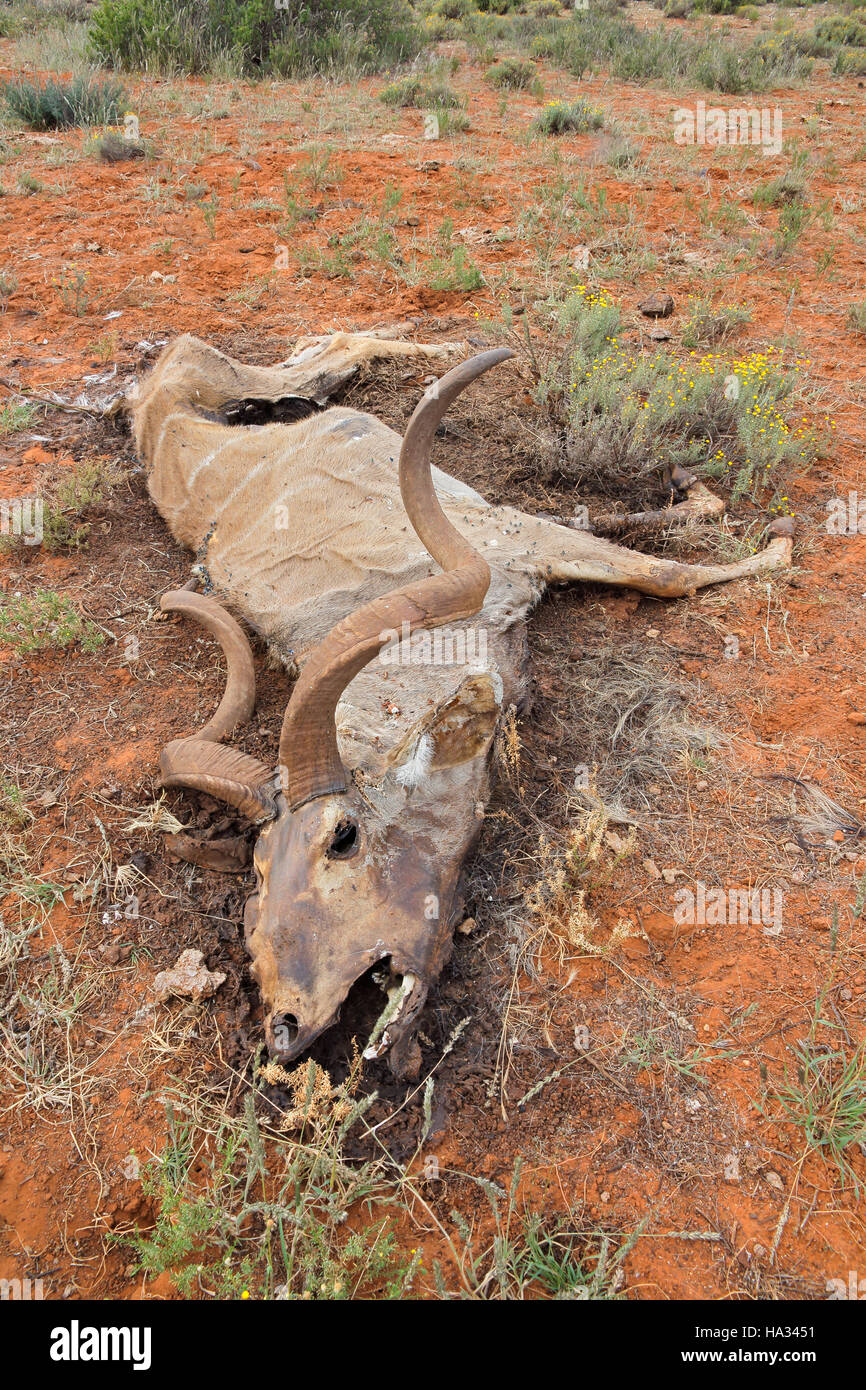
[90,0,424,76]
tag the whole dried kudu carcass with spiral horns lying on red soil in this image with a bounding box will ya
[129,334,792,1069]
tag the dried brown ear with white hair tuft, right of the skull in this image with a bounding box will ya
[388,671,502,787]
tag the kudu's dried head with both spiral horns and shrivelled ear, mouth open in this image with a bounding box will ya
[154,349,512,1061]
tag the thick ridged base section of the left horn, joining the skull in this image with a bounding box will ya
[160,738,277,821]
